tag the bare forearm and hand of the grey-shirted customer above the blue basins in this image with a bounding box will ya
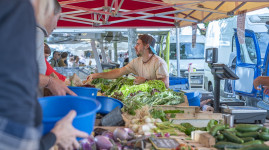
[39,74,76,96]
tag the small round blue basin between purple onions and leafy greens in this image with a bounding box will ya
[96,96,123,114]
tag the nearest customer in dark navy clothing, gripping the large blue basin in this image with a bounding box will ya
[0,0,87,150]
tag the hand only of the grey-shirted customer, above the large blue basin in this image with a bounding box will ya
[47,78,77,96]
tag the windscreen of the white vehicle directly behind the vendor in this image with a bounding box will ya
[170,43,205,59]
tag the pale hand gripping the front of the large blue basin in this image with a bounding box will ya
[51,110,89,150]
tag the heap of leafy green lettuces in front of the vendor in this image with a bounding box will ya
[92,77,184,115]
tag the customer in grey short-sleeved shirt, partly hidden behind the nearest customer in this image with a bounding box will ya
[36,0,75,95]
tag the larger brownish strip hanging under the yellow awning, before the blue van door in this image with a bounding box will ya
[237,10,247,44]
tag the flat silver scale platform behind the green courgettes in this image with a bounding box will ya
[221,106,267,124]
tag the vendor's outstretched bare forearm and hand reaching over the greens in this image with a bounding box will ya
[88,67,130,79]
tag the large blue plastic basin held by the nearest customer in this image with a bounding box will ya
[39,96,101,135]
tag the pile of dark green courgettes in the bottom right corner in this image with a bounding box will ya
[207,120,269,150]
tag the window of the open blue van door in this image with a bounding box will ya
[240,37,257,64]
